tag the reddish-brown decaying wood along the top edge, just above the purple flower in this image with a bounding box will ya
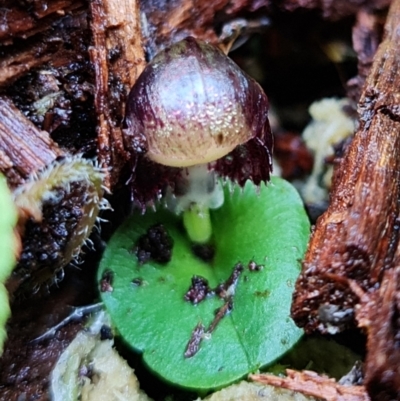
[141,0,390,55]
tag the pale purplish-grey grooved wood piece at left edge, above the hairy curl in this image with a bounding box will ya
[0,97,63,187]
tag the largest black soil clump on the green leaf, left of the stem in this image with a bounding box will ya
[136,224,174,265]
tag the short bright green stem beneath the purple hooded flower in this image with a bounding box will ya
[183,203,212,244]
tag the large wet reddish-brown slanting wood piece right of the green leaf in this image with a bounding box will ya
[292,1,400,332]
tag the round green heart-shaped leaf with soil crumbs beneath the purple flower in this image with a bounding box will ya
[98,178,310,390]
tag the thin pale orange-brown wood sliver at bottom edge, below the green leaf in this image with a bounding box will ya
[249,369,370,401]
